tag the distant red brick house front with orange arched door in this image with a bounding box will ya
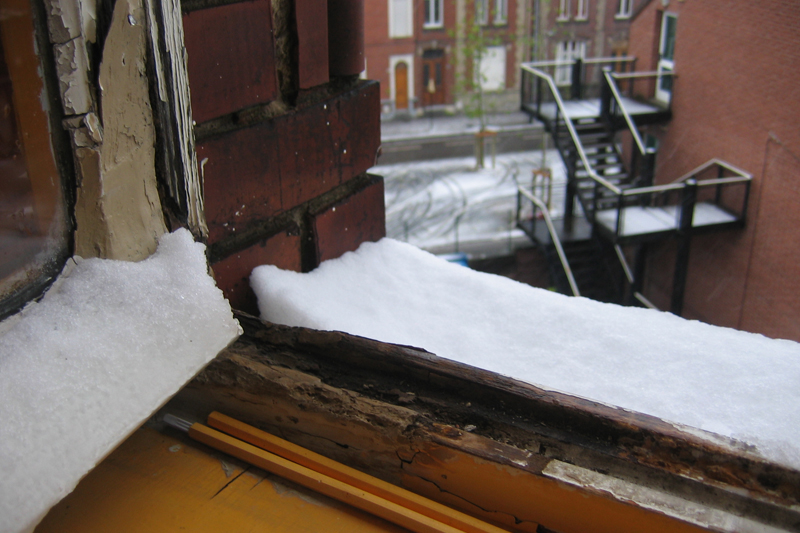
[365,0,532,114]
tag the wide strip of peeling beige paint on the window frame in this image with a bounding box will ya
[73,0,166,261]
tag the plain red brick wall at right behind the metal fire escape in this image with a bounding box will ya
[629,0,800,341]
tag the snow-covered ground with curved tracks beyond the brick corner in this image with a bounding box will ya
[378,150,566,258]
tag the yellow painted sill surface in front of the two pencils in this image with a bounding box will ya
[36,428,406,533]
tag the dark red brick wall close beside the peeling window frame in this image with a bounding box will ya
[183,0,385,313]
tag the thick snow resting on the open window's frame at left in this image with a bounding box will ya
[0,230,239,532]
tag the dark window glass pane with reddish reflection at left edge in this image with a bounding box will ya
[0,18,69,317]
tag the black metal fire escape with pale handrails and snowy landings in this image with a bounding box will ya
[517,57,752,315]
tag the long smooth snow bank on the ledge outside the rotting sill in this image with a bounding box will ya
[251,239,800,468]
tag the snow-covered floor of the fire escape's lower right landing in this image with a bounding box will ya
[595,202,741,242]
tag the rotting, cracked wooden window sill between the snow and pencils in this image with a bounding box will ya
[161,314,800,531]
